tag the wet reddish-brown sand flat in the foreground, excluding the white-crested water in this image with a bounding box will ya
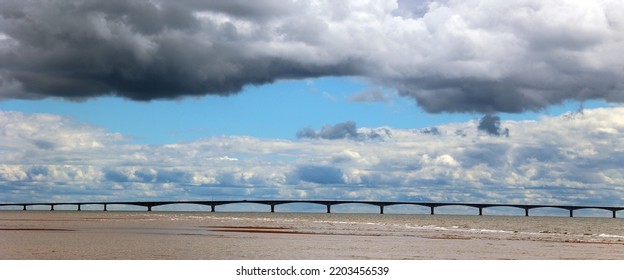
[0,211,624,260]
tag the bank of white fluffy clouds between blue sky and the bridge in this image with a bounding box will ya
[0,108,624,205]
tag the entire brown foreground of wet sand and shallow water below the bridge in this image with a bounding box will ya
[0,211,624,260]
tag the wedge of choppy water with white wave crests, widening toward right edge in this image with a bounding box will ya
[199,213,624,241]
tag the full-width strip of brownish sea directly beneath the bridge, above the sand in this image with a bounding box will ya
[0,211,624,241]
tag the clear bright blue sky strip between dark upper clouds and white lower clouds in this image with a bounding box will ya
[0,77,609,144]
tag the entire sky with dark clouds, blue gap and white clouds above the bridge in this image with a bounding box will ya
[0,0,624,214]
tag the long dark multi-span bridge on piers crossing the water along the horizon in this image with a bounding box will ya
[0,200,624,218]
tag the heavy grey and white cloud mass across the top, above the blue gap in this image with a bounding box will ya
[0,0,624,113]
